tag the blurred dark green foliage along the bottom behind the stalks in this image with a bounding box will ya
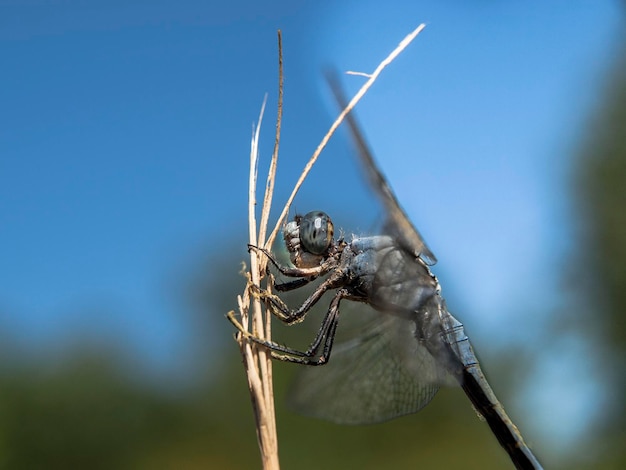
[0,342,507,469]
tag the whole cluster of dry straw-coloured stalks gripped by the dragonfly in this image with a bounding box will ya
[228,24,425,470]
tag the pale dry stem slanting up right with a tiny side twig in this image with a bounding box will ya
[264,23,426,249]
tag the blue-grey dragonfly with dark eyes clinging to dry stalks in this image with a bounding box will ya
[231,82,542,469]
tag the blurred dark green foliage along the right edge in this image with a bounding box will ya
[573,40,626,468]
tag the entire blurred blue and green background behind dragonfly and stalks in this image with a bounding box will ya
[0,0,626,469]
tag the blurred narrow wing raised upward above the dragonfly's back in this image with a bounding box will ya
[327,73,437,265]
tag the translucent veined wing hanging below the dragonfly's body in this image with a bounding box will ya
[289,312,450,424]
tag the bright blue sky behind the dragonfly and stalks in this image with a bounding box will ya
[0,1,623,460]
